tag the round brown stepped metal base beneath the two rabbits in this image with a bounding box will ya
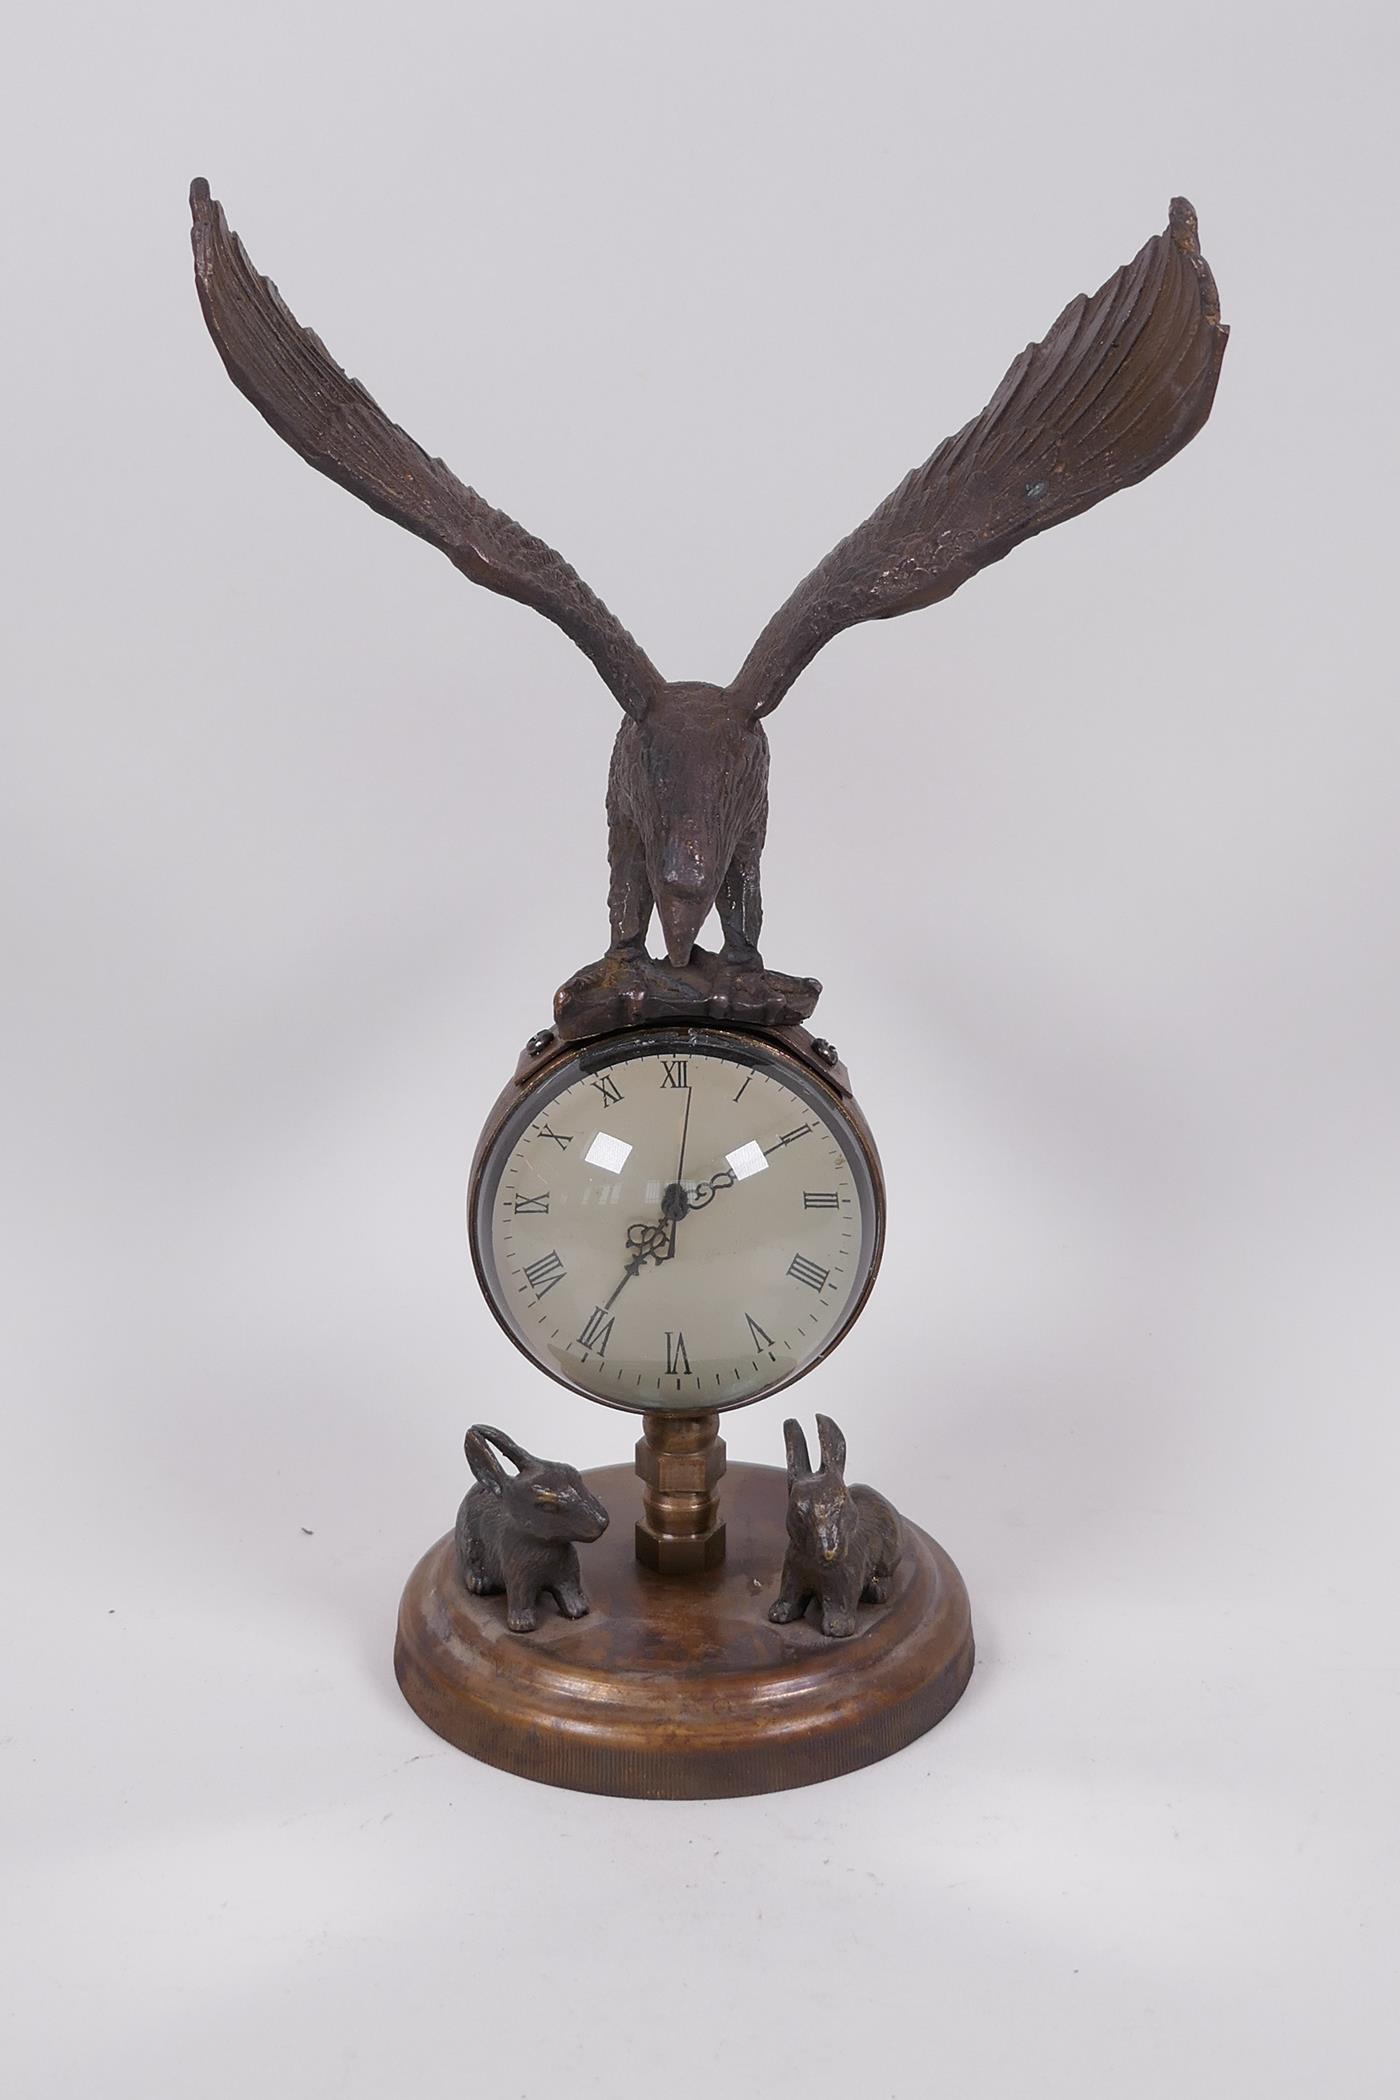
[395,1466,972,1800]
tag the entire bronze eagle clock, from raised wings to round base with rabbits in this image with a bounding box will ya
[191,181,1226,1798]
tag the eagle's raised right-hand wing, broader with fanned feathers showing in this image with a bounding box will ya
[730,197,1228,714]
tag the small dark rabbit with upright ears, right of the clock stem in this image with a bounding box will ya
[768,1415,900,1640]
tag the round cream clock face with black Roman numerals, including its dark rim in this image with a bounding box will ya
[470,1029,882,1411]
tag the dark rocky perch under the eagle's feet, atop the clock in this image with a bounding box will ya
[554,947,821,1042]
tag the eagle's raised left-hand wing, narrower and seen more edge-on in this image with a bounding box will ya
[189,179,663,716]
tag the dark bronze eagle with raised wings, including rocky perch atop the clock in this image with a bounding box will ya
[189,179,1228,1035]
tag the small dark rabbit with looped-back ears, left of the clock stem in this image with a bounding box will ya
[455,1422,609,1634]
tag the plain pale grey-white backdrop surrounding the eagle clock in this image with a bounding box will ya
[0,0,1400,2100]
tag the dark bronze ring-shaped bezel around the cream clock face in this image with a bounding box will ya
[466,1021,886,1418]
